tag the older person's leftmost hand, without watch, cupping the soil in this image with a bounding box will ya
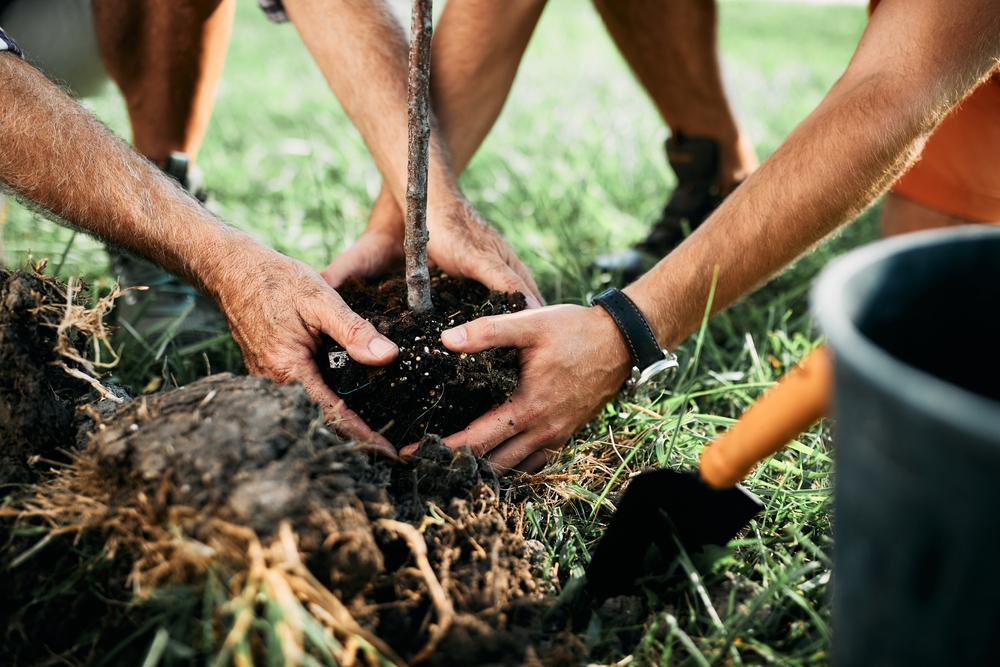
[213,244,399,459]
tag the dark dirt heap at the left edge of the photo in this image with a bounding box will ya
[0,260,127,486]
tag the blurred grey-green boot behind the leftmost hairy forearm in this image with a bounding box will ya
[108,153,229,348]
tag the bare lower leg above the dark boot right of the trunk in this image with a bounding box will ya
[594,0,757,193]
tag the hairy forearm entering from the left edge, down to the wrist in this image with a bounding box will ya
[0,54,262,292]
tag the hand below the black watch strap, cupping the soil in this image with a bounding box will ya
[400,305,632,474]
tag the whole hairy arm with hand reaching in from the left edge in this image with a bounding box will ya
[0,53,398,456]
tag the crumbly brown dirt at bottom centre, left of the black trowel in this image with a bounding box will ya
[366,436,585,665]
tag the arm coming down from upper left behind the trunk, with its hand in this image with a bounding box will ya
[285,0,541,302]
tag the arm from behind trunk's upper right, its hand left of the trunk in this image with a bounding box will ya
[322,0,545,288]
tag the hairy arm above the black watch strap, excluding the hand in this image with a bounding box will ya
[627,0,1000,346]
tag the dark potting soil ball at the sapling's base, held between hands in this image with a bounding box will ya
[317,271,526,447]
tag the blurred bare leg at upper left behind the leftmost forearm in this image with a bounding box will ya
[94,0,236,166]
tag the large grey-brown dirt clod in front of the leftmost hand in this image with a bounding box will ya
[88,374,393,598]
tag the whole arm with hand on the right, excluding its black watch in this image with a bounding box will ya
[412,0,1000,469]
